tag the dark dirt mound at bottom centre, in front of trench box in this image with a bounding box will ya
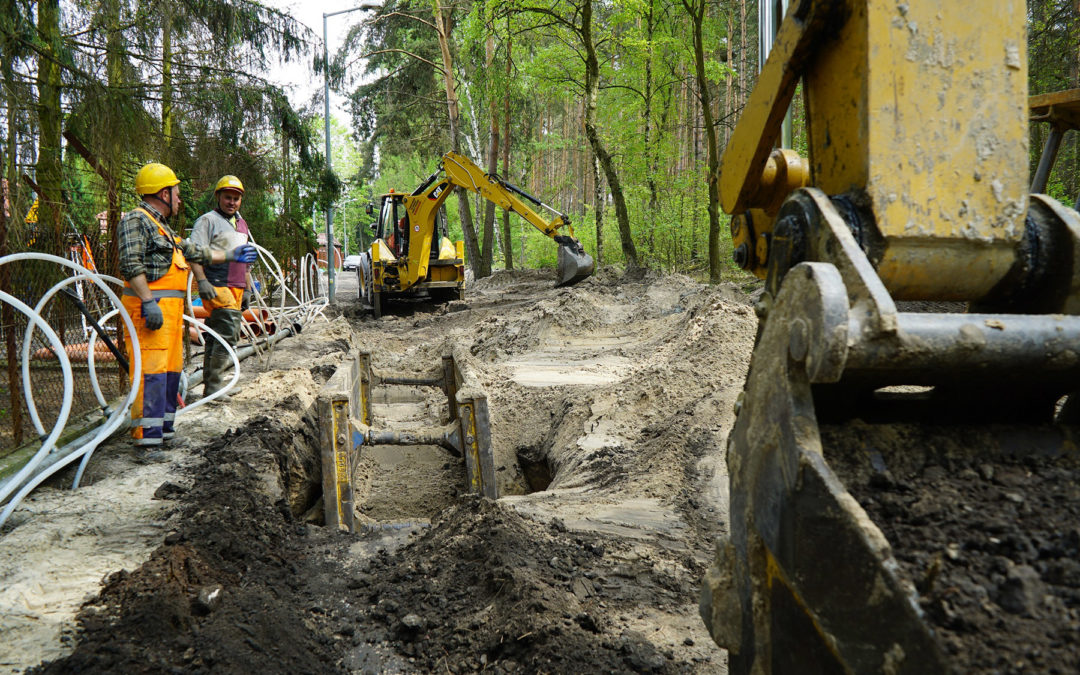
[324,499,693,673]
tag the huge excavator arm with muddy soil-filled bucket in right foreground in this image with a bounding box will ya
[701,0,1080,674]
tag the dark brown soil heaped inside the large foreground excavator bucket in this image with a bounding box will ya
[824,422,1080,673]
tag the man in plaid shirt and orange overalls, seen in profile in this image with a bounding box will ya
[119,163,256,446]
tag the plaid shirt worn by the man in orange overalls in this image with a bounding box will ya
[120,202,211,282]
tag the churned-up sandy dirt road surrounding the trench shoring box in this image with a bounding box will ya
[0,272,756,673]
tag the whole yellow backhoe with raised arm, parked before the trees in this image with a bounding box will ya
[356,152,593,318]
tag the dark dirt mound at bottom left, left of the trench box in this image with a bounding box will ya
[36,419,336,673]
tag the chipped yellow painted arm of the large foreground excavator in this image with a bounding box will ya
[720,0,1028,299]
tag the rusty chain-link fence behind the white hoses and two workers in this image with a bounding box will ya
[0,174,311,462]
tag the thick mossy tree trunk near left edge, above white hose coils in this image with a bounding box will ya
[35,0,63,255]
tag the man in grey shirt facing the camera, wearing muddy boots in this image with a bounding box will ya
[191,176,252,397]
